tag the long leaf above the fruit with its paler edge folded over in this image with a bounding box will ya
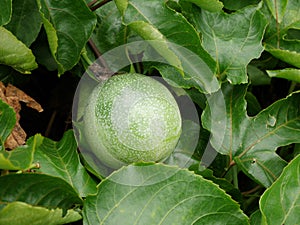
[115,0,219,93]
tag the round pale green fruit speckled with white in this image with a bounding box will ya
[83,73,182,169]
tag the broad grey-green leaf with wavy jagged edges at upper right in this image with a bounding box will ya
[194,5,267,84]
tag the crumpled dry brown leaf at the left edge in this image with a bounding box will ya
[0,81,43,149]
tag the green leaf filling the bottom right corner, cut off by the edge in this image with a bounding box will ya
[260,155,300,225]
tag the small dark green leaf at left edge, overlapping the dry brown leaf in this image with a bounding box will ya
[0,99,16,149]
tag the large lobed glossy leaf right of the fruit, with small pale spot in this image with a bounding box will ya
[202,84,300,187]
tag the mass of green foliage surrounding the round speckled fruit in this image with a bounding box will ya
[0,0,300,225]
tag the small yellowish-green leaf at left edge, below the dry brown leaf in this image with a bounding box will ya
[0,134,43,170]
